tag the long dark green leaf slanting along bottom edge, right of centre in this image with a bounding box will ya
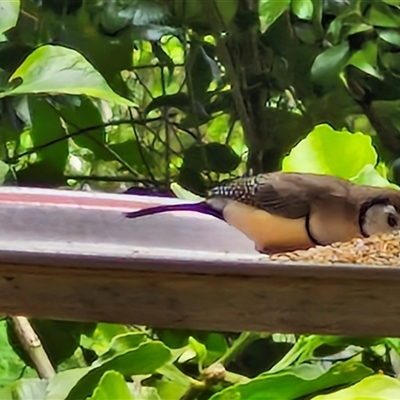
[210,361,373,400]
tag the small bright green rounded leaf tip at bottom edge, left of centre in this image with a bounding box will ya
[90,371,134,400]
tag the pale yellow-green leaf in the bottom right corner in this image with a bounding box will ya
[312,375,400,400]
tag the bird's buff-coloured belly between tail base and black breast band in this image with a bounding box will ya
[223,201,313,252]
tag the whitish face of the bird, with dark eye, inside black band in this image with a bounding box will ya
[363,204,400,235]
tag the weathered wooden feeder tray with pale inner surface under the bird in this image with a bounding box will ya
[0,188,400,336]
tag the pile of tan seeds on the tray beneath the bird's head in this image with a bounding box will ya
[270,233,400,266]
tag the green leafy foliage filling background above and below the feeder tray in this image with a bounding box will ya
[0,0,400,400]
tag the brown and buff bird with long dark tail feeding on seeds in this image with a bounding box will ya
[125,171,400,254]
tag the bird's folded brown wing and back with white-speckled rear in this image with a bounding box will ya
[210,172,352,219]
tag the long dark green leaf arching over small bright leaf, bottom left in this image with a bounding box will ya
[65,341,171,400]
